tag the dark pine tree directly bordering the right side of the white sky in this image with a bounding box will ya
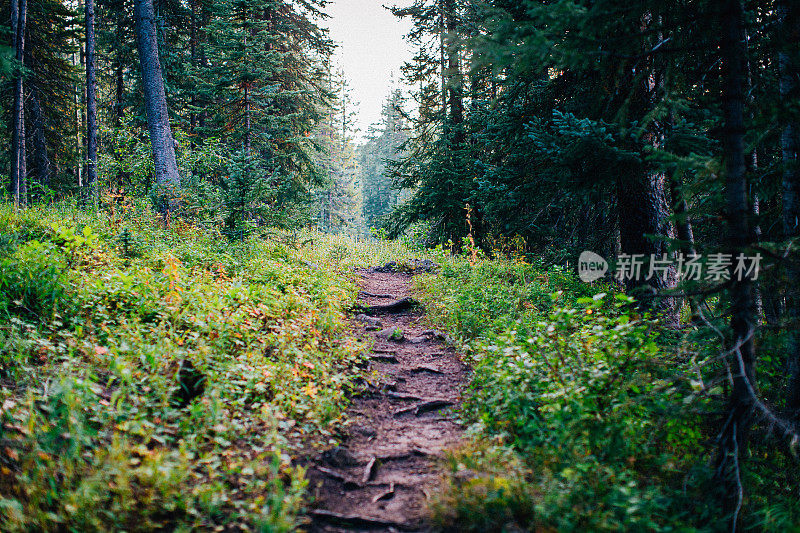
[391,0,481,247]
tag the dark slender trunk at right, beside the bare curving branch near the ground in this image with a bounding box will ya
[716,0,755,530]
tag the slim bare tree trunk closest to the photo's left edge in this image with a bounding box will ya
[11,0,28,207]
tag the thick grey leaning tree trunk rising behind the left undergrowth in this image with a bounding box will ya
[134,0,180,195]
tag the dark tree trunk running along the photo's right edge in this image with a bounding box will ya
[778,0,800,421]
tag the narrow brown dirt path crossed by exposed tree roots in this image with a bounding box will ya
[308,269,467,532]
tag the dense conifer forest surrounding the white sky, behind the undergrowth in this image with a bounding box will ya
[0,0,800,527]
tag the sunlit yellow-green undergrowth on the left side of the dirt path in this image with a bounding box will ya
[0,204,407,531]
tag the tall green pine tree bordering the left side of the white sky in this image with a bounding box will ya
[204,0,331,231]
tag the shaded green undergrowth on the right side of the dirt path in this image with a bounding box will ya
[416,255,798,532]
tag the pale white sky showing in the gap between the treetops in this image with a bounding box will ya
[323,0,413,140]
